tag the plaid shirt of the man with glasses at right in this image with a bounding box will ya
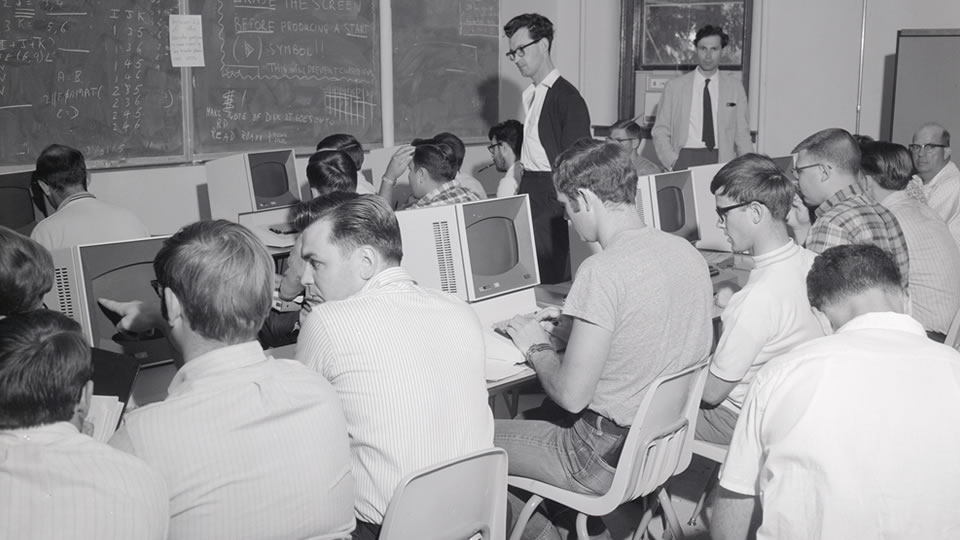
[804,184,910,289]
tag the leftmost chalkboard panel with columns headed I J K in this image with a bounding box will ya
[0,0,184,165]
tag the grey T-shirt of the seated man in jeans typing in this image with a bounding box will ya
[563,227,713,426]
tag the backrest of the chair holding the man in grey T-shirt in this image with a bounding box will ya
[607,360,707,502]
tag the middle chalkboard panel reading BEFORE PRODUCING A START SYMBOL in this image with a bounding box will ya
[190,0,383,154]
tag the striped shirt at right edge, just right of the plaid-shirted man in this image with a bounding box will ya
[880,191,960,334]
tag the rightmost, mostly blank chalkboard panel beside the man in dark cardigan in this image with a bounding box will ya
[392,0,503,142]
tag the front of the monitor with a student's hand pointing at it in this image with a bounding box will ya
[77,238,173,365]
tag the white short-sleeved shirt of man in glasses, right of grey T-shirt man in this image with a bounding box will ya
[710,241,823,414]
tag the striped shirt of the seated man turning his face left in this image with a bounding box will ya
[297,267,493,523]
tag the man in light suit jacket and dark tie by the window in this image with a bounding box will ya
[653,25,753,170]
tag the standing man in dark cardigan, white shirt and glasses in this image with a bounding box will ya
[503,13,590,283]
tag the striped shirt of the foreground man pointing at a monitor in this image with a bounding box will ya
[110,342,354,540]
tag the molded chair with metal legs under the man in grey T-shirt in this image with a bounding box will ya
[508,361,707,540]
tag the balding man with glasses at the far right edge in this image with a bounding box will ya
[908,123,960,245]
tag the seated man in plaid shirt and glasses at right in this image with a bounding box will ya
[789,128,910,287]
